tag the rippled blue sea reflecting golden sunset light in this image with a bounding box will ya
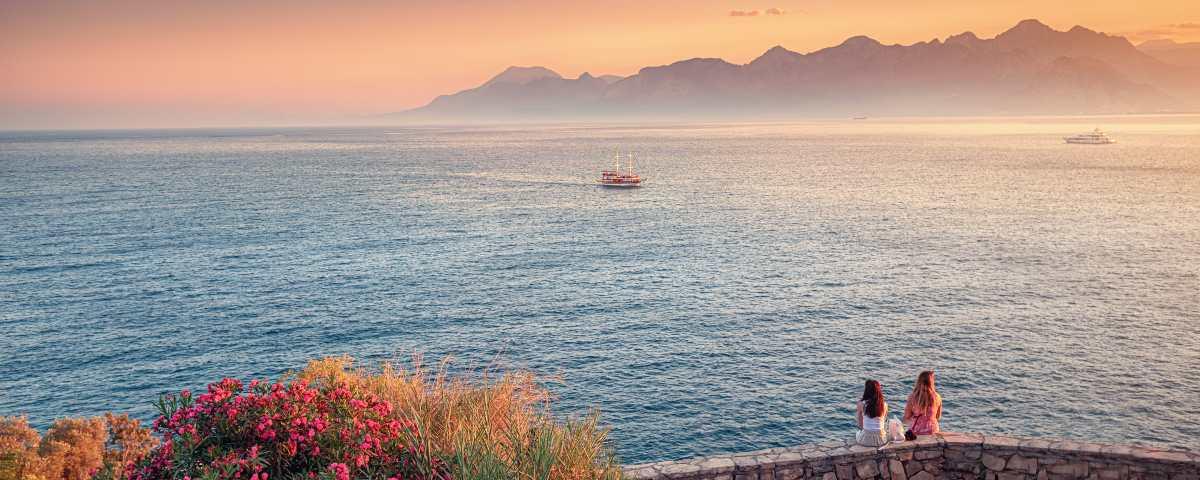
[0,118,1200,462]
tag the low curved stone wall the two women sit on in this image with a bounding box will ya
[625,433,1200,480]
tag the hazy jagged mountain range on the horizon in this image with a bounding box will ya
[388,19,1200,121]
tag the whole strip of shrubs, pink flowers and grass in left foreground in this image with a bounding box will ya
[0,358,620,480]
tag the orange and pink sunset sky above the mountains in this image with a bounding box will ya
[7,0,1200,130]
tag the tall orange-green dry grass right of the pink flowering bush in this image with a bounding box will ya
[296,356,620,480]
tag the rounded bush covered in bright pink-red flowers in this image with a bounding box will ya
[130,378,448,480]
